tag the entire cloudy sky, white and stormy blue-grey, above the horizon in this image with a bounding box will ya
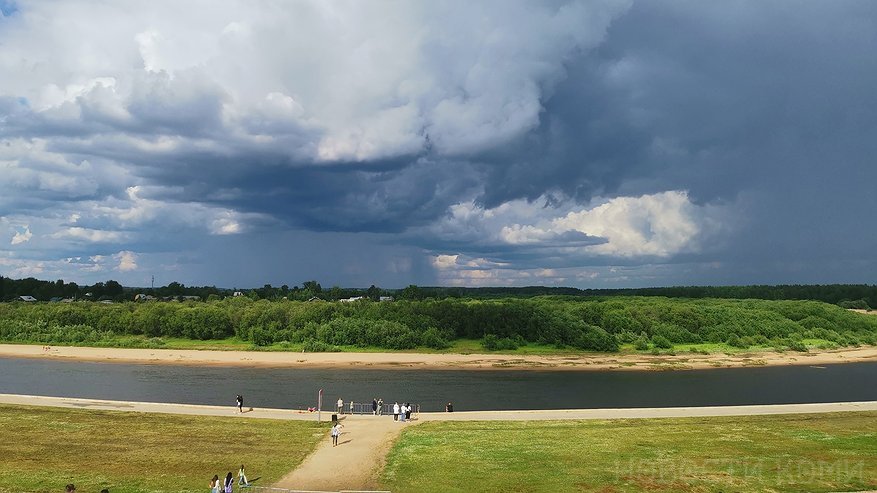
[0,0,877,288]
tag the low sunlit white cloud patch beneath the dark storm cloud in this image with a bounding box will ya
[430,191,734,285]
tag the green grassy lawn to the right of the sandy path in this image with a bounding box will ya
[382,412,877,493]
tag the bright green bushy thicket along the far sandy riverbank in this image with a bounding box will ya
[0,296,877,351]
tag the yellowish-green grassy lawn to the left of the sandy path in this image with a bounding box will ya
[0,405,325,493]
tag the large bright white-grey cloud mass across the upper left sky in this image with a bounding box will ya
[0,0,628,161]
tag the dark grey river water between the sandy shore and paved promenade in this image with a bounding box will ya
[0,358,877,411]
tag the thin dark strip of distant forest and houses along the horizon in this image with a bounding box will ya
[0,276,877,308]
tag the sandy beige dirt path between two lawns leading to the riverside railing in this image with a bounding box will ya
[274,416,411,491]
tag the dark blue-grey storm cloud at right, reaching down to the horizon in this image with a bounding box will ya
[452,2,877,283]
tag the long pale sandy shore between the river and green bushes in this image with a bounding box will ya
[0,344,877,370]
